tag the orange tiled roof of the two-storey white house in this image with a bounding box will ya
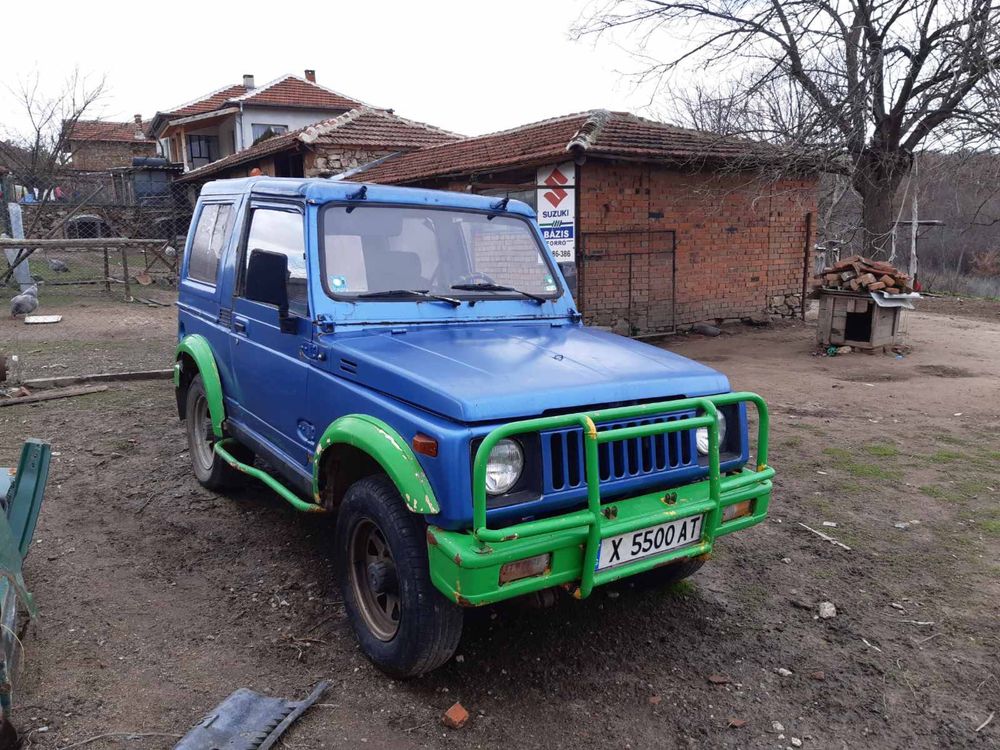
[161,75,361,119]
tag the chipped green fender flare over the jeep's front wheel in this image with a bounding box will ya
[313,414,441,513]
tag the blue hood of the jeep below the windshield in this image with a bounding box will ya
[324,322,729,422]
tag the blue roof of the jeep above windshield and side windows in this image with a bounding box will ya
[201,176,535,218]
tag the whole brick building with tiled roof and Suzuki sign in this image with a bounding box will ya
[354,110,818,335]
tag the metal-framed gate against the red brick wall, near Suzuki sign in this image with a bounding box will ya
[579,229,676,336]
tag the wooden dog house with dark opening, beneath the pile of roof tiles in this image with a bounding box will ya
[816,289,903,350]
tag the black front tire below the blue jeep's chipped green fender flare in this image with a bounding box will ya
[334,474,463,679]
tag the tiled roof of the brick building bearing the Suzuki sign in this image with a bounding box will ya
[353,109,776,183]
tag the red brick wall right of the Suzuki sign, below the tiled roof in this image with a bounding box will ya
[577,160,817,333]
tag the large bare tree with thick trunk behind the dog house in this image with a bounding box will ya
[575,0,1000,255]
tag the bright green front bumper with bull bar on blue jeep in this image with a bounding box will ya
[427,393,774,606]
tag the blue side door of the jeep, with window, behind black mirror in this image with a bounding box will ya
[230,203,313,466]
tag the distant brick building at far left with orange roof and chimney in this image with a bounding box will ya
[64,115,156,172]
